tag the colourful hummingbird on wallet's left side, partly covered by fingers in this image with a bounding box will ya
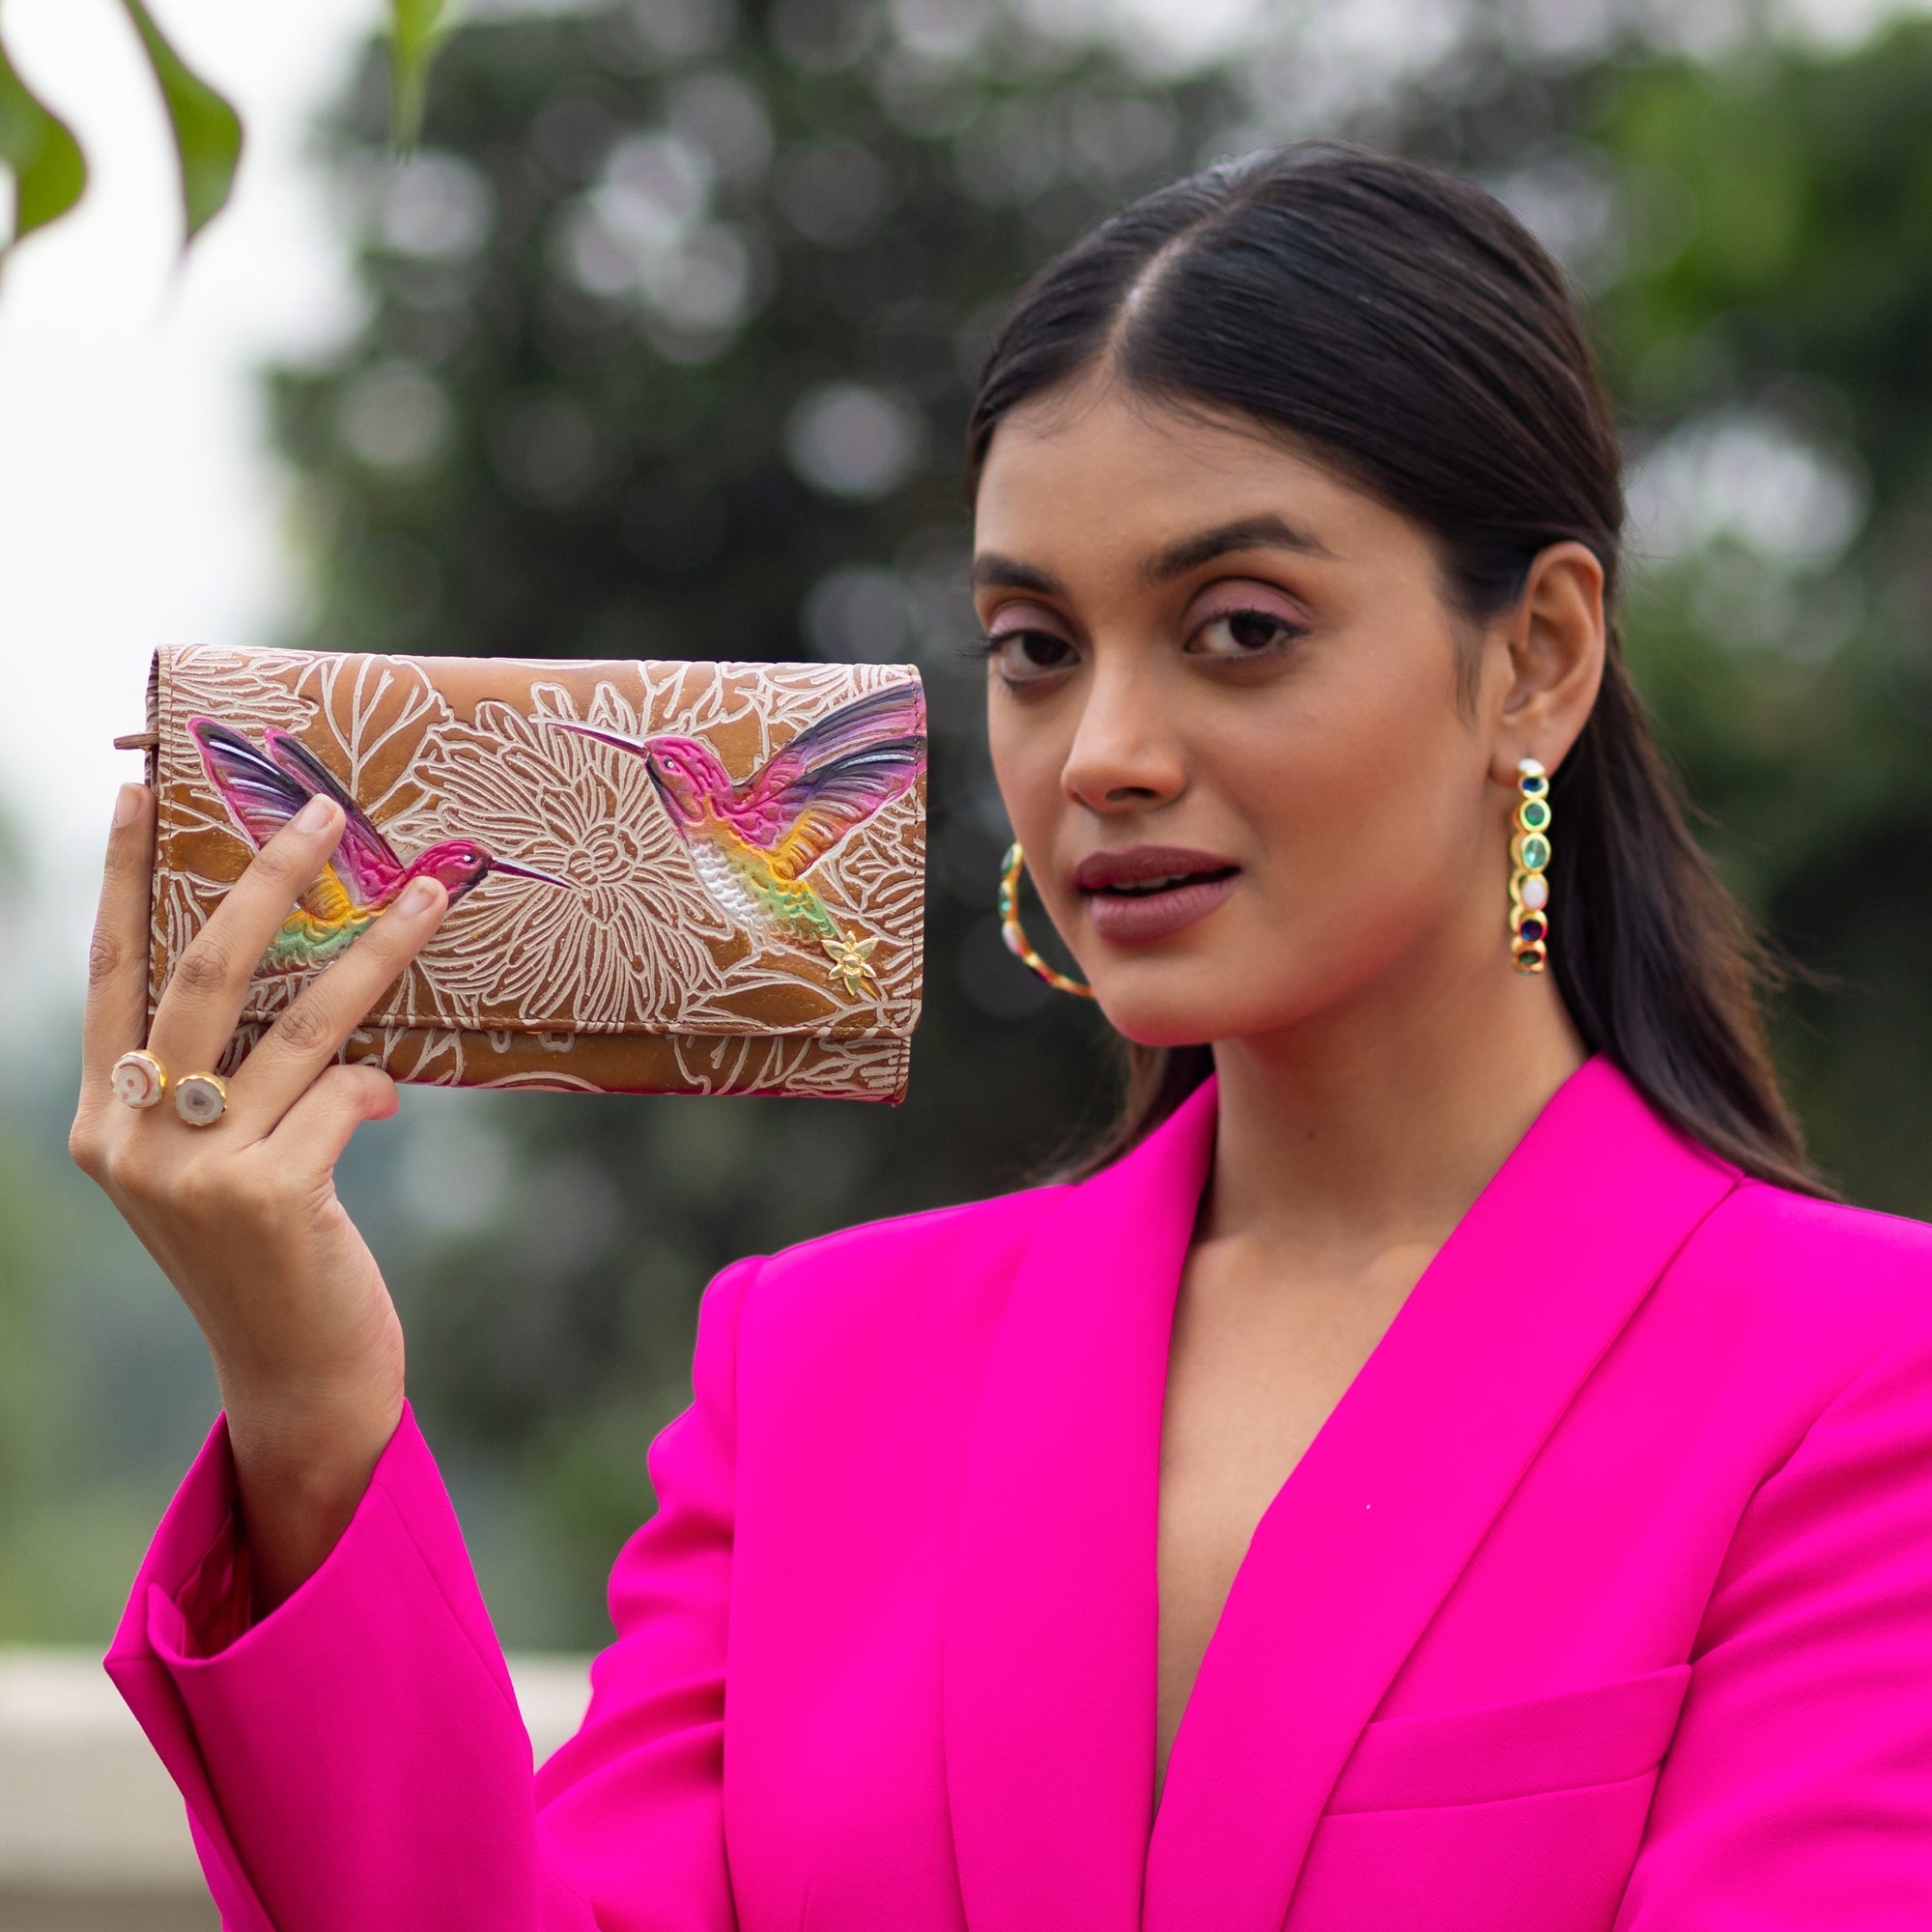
[187,719,568,972]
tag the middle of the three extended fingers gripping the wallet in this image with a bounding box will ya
[149,794,342,1078]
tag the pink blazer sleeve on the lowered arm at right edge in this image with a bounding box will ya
[1615,1325,1932,1932]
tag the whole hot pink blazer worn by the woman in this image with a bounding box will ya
[108,1061,1932,1932]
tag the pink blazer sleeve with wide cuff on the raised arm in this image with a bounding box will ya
[106,1262,757,1932]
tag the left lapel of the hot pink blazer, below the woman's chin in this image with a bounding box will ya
[945,1082,1213,1932]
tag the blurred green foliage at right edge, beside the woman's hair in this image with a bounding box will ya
[1598,38,1932,1215]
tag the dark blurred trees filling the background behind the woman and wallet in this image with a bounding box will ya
[14,0,1932,1646]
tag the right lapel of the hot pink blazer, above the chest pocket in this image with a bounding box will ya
[1136,1059,1737,1932]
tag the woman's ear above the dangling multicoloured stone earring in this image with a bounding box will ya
[1493,543,1605,784]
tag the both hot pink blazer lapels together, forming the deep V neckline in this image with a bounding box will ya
[943,1059,1737,1932]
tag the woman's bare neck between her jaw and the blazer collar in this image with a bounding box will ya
[1202,945,1586,1265]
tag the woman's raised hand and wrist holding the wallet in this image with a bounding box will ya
[70,784,448,1613]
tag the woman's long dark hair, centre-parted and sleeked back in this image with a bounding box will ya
[968,143,1826,1194]
